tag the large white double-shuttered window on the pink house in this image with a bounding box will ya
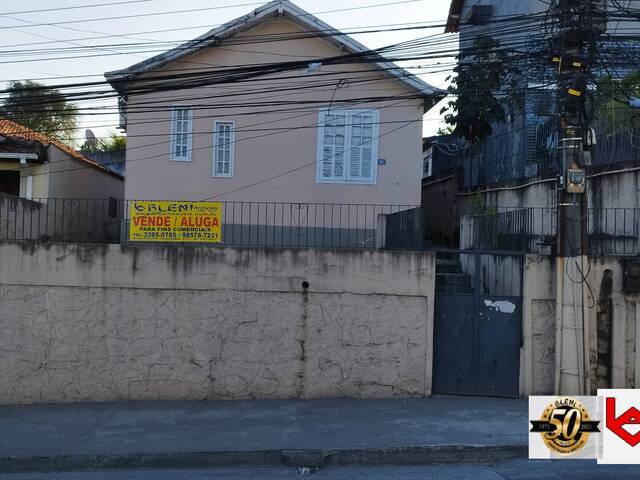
[316,110,379,184]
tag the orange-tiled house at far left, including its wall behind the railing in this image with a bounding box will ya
[0,119,124,242]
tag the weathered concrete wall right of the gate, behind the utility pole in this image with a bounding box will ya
[521,255,640,395]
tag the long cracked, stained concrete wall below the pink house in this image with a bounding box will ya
[0,244,435,404]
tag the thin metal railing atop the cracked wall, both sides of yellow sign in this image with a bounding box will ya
[0,195,415,249]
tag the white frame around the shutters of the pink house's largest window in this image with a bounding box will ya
[316,108,380,185]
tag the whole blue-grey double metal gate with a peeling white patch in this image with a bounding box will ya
[433,252,522,397]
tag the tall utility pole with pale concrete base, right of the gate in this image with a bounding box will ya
[556,0,589,395]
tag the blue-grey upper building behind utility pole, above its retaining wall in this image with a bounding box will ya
[445,0,640,188]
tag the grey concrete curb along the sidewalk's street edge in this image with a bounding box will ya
[0,445,528,473]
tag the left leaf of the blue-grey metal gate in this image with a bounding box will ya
[433,293,474,395]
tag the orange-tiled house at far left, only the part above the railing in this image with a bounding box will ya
[0,119,124,199]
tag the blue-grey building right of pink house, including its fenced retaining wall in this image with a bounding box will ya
[410,0,640,254]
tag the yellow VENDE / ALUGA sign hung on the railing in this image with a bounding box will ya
[129,201,222,243]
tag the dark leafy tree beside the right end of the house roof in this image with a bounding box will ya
[440,35,522,143]
